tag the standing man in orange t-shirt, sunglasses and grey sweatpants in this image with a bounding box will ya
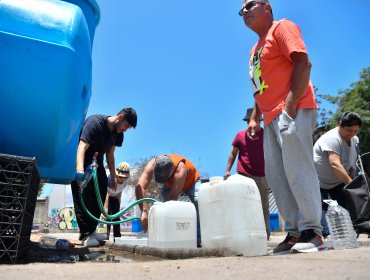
[239,0,326,254]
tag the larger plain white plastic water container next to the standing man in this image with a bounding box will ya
[198,174,267,256]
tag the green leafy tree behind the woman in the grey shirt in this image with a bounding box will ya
[320,67,370,152]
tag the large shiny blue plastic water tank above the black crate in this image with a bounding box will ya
[0,0,99,183]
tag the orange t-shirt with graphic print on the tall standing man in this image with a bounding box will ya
[249,20,318,126]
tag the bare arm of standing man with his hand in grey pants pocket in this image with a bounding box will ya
[284,52,312,119]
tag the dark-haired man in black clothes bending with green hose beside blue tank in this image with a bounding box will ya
[71,108,137,247]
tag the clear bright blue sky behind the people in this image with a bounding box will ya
[87,0,370,177]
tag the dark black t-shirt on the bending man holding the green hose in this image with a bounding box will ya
[80,115,124,168]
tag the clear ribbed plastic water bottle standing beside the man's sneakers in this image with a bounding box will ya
[324,200,358,250]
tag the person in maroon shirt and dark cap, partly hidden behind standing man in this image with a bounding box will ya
[224,108,270,240]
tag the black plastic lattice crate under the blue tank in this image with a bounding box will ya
[0,154,40,263]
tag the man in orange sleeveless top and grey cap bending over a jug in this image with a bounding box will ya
[136,154,201,247]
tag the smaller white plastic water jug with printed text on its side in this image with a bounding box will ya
[148,200,197,248]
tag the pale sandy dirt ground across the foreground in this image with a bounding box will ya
[0,231,370,280]
